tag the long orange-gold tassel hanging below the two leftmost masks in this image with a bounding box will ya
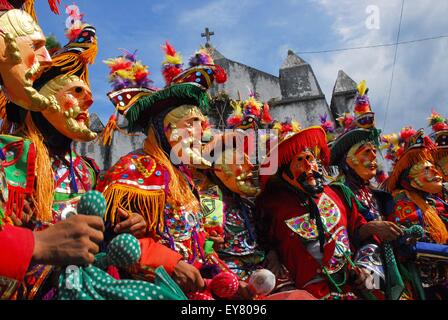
[25,113,54,222]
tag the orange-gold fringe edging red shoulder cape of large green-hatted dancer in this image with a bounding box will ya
[103,185,165,231]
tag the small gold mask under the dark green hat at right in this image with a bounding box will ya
[346,143,378,182]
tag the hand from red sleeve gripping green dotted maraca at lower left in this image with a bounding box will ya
[32,215,104,266]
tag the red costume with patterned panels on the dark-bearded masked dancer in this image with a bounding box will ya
[258,181,366,298]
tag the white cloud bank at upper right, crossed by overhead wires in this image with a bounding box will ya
[304,0,448,131]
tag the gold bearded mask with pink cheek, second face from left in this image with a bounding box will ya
[39,76,96,141]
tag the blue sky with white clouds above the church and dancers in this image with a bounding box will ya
[36,0,448,133]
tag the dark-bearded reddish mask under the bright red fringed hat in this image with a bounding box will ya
[282,149,324,195]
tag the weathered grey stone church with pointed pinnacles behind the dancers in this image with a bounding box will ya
[75,38,356,169]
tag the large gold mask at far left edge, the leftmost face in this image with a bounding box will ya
[0,10,56,111]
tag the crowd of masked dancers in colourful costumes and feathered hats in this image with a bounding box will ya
[0,0,448,300]
